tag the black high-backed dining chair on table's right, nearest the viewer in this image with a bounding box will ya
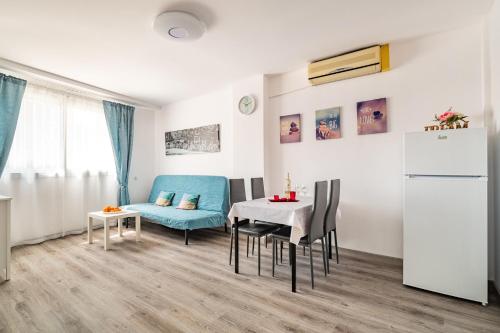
[271,181,328,289]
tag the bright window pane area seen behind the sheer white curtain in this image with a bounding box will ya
[6,85,115,175]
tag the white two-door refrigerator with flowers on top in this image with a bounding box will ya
[403,128,488,305]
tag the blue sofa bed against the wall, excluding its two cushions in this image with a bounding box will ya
[122,175,229,245]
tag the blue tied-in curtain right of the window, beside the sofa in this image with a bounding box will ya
[102,101,135,206]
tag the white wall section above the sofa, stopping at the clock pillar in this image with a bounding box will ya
[154,88,234,176]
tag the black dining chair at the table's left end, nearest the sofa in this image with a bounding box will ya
[229,178,277,275]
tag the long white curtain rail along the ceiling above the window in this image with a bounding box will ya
[0,58,161,110]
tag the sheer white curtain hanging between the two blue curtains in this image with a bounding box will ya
[0,85,117,244]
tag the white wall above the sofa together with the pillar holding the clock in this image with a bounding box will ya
[155,75,264,197]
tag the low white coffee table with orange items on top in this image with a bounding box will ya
[88,210,141,251]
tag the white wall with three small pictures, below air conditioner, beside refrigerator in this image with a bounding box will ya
[266,25,483,257]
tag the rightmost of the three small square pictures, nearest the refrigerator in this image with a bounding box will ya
[357,98,387,135]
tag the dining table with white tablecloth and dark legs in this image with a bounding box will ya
[228,197,314,292]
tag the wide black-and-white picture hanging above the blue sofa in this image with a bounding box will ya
[165,124,220,155]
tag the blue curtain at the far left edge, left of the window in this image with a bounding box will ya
[0,73,26,176]
